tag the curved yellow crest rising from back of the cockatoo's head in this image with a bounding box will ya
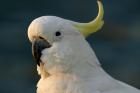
[74,1,104,37]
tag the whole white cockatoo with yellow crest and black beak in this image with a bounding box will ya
[28,1,140,93]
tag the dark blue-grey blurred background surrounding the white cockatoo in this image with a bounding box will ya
[0,0,140,93]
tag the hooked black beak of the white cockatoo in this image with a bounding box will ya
[32,38,51,66]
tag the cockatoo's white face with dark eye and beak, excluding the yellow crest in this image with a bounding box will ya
[28,16,85,73]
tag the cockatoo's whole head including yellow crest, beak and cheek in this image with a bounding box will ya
[28,1,103,74]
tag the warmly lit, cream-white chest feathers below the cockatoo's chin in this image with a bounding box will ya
[37,75,87,93]
